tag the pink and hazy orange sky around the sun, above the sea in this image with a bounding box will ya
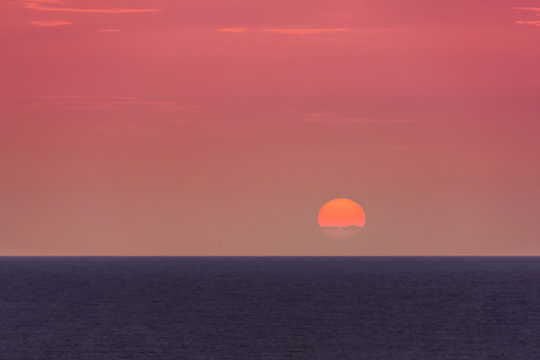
[0,0,540,256]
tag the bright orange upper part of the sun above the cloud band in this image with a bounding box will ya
[319,198,366,227]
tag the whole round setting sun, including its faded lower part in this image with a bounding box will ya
[318,198,366,237]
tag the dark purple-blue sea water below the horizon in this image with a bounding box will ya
[0,258,540,360]
